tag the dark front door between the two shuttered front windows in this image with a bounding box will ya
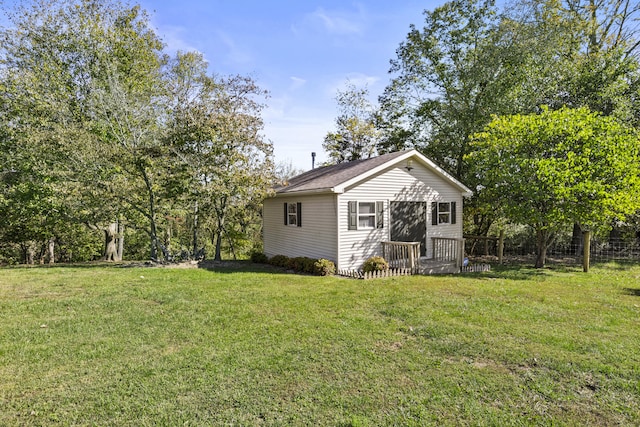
[389,202,427,256]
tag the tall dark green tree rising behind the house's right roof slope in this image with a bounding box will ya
[379,0,524,179]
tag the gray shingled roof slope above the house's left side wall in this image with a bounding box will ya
[275,150,409,194]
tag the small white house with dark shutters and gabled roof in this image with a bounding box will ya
[263,150,472,270]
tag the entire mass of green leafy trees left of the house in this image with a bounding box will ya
[0,0,273,259]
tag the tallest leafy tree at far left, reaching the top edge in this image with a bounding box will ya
[1,0,170,259]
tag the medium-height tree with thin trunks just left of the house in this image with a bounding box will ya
[167,53,273,260]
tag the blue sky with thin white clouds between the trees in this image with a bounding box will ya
[140,0,443,170]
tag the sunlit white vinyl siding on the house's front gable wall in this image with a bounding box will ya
[338,162,462,270]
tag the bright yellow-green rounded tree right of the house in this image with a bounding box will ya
[467,107,640,268]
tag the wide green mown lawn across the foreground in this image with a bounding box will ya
[0,264,640,426]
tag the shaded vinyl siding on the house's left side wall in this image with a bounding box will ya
[263,194,337,262]
